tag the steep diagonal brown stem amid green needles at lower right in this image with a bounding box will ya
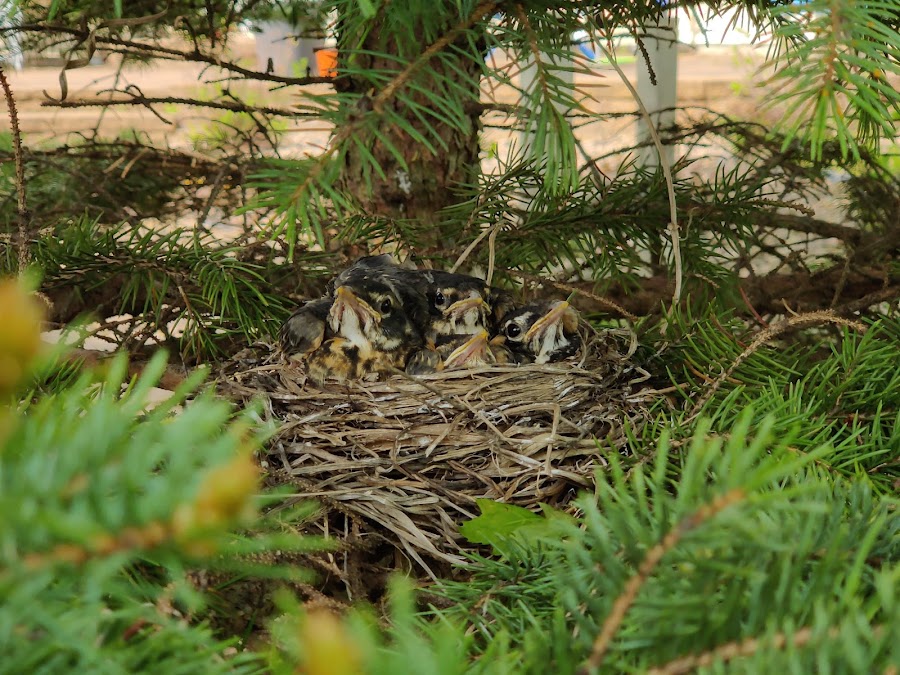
[578,488,746,675]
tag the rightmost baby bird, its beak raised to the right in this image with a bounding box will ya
[500,300,581,363]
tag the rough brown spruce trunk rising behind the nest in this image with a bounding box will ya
[335,11,483,249]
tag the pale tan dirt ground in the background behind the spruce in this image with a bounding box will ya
[4,33,816,218]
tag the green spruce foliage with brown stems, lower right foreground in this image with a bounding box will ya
[435,408,900,673]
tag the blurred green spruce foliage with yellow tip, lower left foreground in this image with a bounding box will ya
[0,282,311,673]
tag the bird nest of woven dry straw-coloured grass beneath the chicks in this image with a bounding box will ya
[219,331,652,596]
